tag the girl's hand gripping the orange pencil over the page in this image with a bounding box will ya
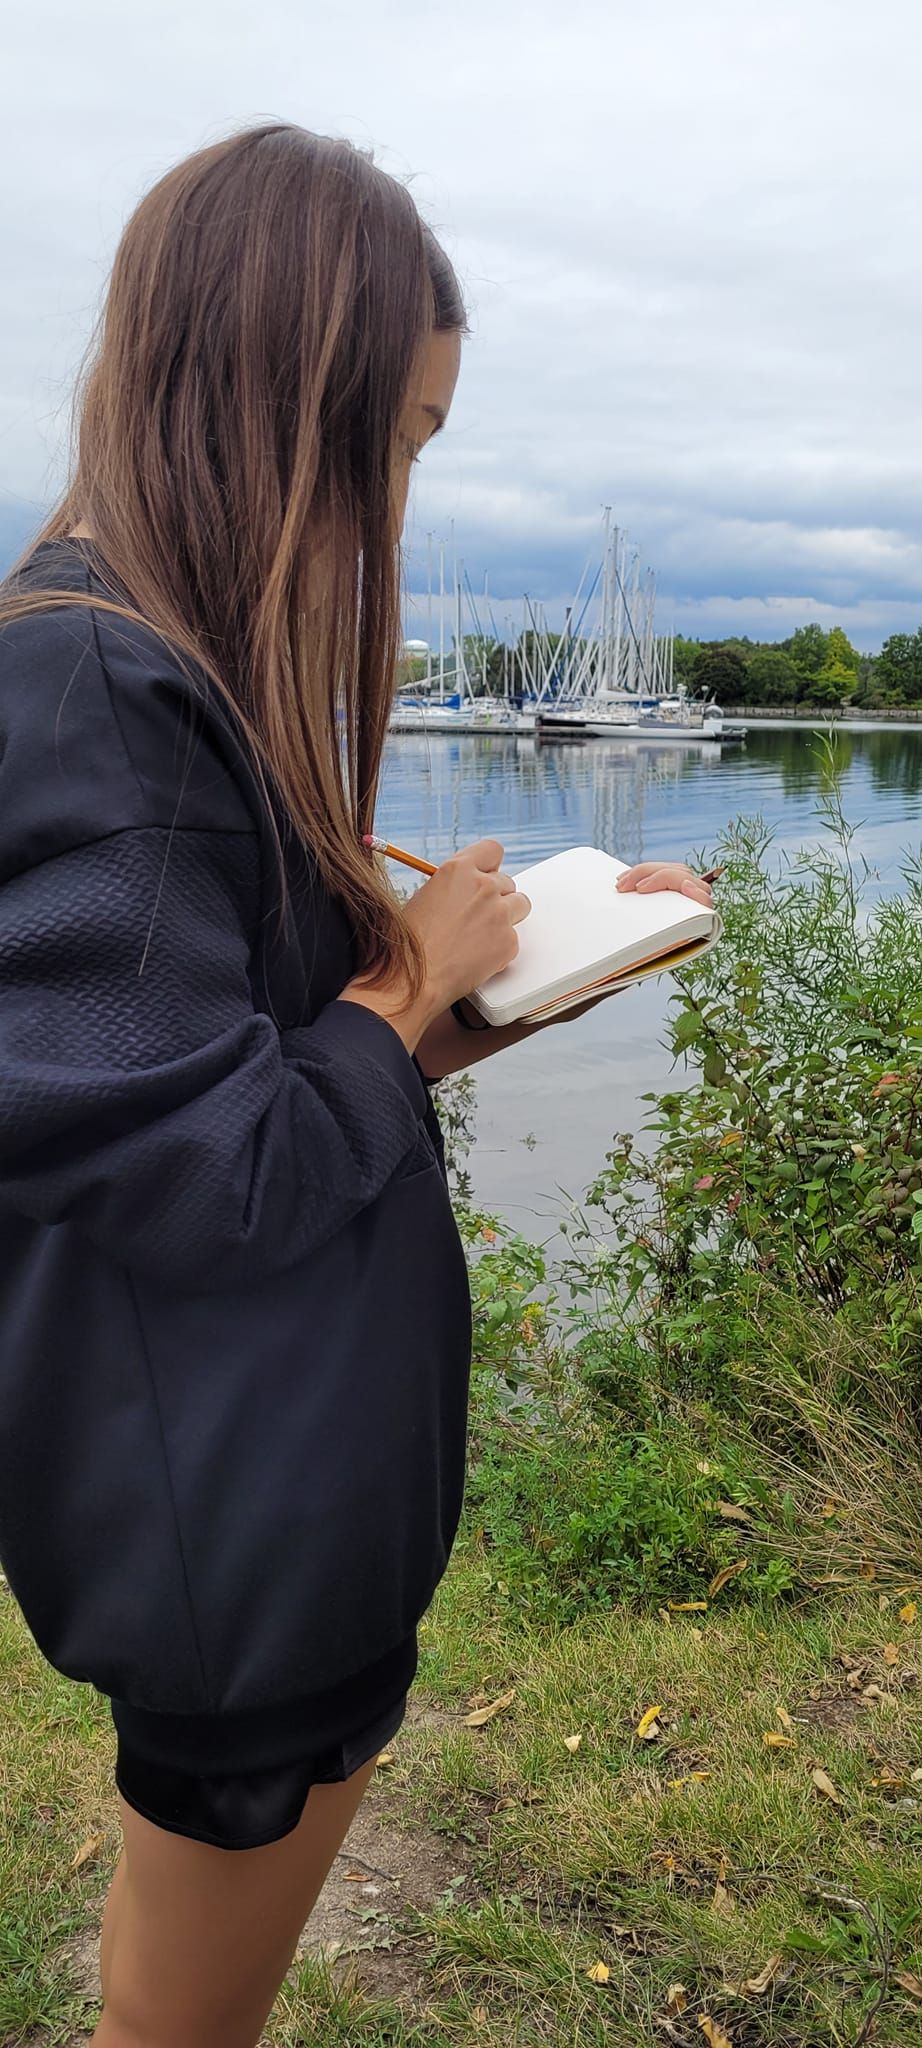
[342,840,531,1051]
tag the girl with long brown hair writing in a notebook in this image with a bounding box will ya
[0,127,707,2048]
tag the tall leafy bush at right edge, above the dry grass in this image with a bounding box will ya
[574,761,922,1370]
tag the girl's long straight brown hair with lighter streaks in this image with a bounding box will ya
[0,125,465,975]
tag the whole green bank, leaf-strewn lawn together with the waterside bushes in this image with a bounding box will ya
[0,790,922,2048]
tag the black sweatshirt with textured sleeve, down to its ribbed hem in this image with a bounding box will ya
[0,543,469,1714]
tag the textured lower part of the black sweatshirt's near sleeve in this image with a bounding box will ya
[0,827,426,1290]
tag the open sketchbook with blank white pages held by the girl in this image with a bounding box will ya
[471,846,721,1024]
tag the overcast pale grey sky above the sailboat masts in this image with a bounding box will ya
[0,0,922,647]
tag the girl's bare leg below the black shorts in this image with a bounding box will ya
[92,1763,375,2048]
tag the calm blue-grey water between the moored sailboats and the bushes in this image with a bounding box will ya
[379,729,922,1229]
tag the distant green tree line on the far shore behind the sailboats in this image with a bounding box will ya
[400,625,922,711]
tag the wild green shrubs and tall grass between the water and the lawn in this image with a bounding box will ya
[463,761,922,1620]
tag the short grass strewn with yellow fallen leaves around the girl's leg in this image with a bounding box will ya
[0,1542,922,2048]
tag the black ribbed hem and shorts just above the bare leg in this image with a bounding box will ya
[111,1638,416,1849]
